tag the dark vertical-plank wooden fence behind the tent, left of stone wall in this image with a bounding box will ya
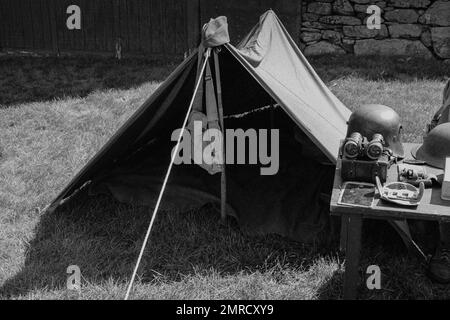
[0,0,301,57]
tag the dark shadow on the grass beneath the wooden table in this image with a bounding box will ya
[318,220,442,300]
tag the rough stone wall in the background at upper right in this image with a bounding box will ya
[300,0,450,62]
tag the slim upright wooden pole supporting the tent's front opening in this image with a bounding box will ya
[213,48,227,222]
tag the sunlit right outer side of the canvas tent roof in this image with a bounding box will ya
[230,10,350,162]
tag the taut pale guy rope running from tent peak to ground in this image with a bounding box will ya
[125,48,211,300]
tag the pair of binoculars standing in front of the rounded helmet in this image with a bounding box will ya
[343,132,385,160]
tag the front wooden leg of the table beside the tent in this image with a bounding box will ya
[341,214,362,300]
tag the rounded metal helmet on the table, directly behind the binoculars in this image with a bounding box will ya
[347,104,405,158]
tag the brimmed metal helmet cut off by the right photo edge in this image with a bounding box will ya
[411,122,450,169]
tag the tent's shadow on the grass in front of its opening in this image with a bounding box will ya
[0,190,336,297]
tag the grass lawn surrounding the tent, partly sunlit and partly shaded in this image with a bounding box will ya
[0,53,450,299]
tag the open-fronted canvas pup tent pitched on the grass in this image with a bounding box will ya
[50,10,350,241]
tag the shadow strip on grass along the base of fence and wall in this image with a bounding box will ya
[0,55,450,107]
